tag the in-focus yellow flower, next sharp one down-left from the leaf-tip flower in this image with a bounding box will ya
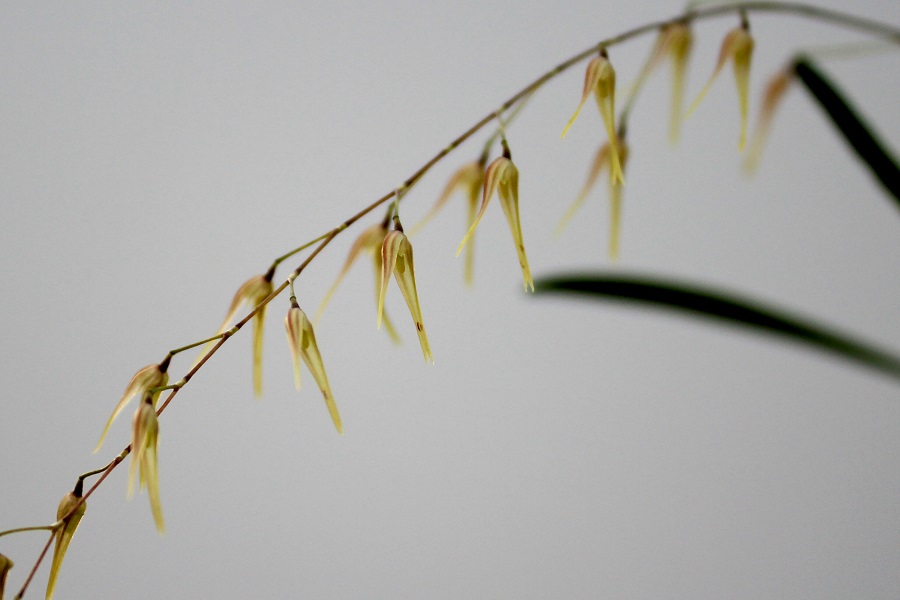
[378,229,434,363]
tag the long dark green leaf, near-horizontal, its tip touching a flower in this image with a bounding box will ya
[535,273,900,379]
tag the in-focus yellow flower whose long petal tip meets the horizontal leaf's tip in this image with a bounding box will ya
[456,149,534,291]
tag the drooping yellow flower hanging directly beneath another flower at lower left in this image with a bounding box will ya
[128,396,166,533]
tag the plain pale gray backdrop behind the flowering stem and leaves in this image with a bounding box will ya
[0,0,900,598]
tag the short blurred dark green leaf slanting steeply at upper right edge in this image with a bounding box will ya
[794,57,900,208]
